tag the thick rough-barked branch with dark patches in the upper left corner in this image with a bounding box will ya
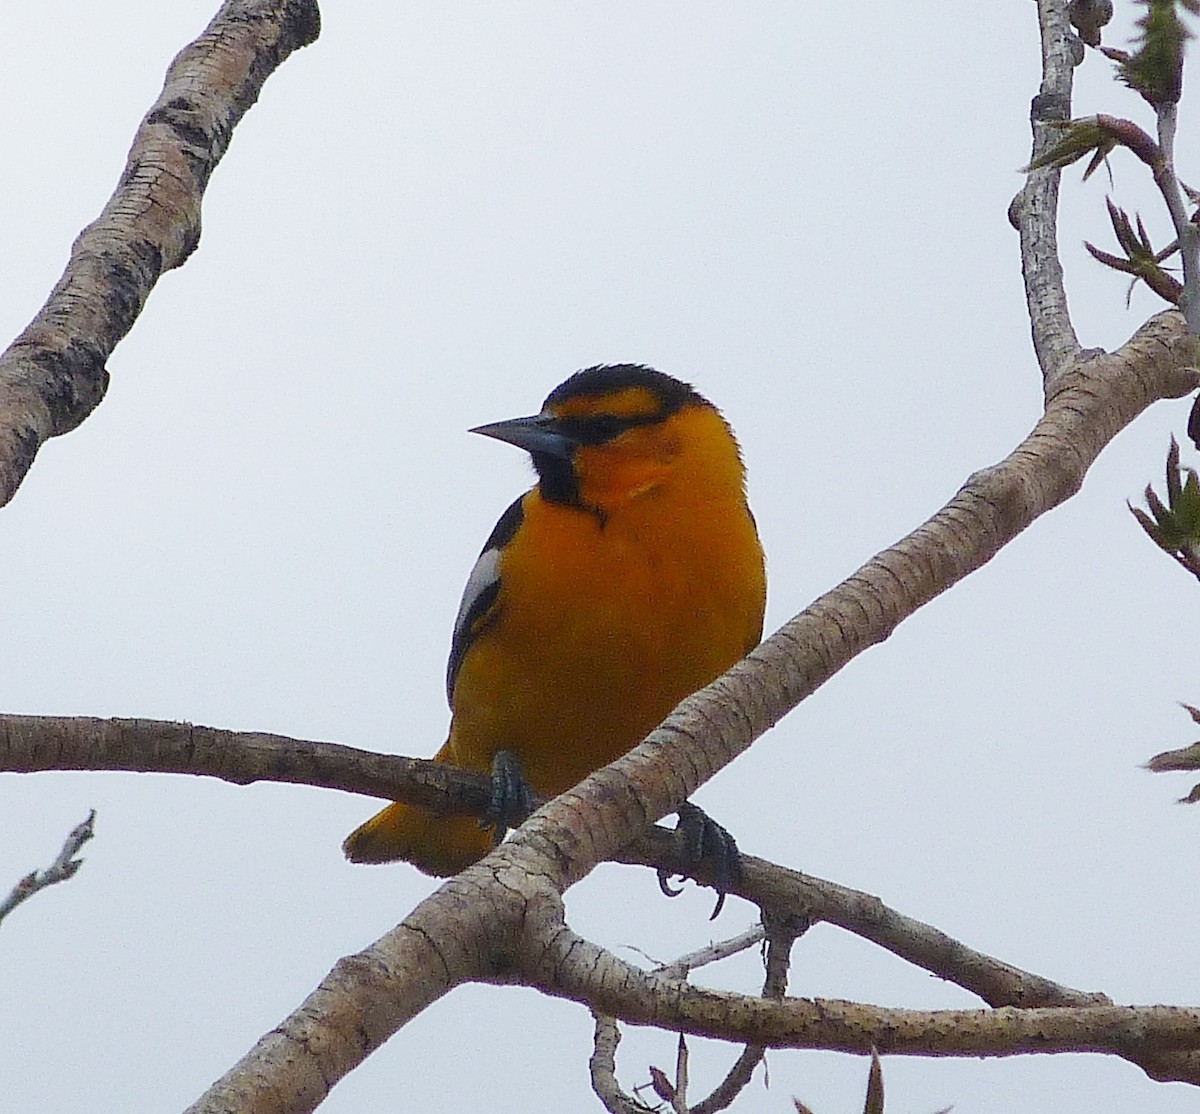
[0,0,320,507]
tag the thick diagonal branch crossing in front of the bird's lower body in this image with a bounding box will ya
[199,312,1200,1114]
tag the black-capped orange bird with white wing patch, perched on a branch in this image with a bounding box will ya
[343,364,767,878]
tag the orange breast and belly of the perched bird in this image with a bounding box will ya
[446,485,766,795]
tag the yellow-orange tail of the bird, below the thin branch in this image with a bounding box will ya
[342,747,492,878]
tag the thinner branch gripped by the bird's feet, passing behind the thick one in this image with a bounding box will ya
[0,715,1123,1006]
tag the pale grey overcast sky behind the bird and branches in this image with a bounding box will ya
[0,0,1200,1114]
